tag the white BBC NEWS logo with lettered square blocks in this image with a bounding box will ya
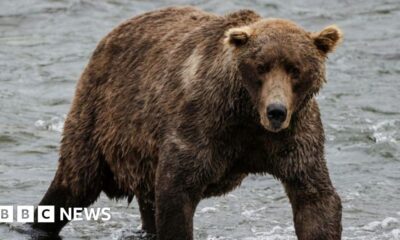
[0,206,111,223]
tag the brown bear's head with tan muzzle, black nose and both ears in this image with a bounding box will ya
[225,19,342,132]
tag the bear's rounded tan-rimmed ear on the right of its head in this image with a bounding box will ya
[311,25,343,54]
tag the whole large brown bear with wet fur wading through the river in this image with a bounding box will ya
[33,7,342,240]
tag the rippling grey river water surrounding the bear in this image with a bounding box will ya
[0,0,400,240]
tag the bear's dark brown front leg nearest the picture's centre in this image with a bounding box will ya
[155,144,223,240]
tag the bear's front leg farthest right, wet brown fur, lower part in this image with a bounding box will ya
[283,159,342,240]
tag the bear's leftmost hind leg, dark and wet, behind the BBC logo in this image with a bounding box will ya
[32,150,105,236]
